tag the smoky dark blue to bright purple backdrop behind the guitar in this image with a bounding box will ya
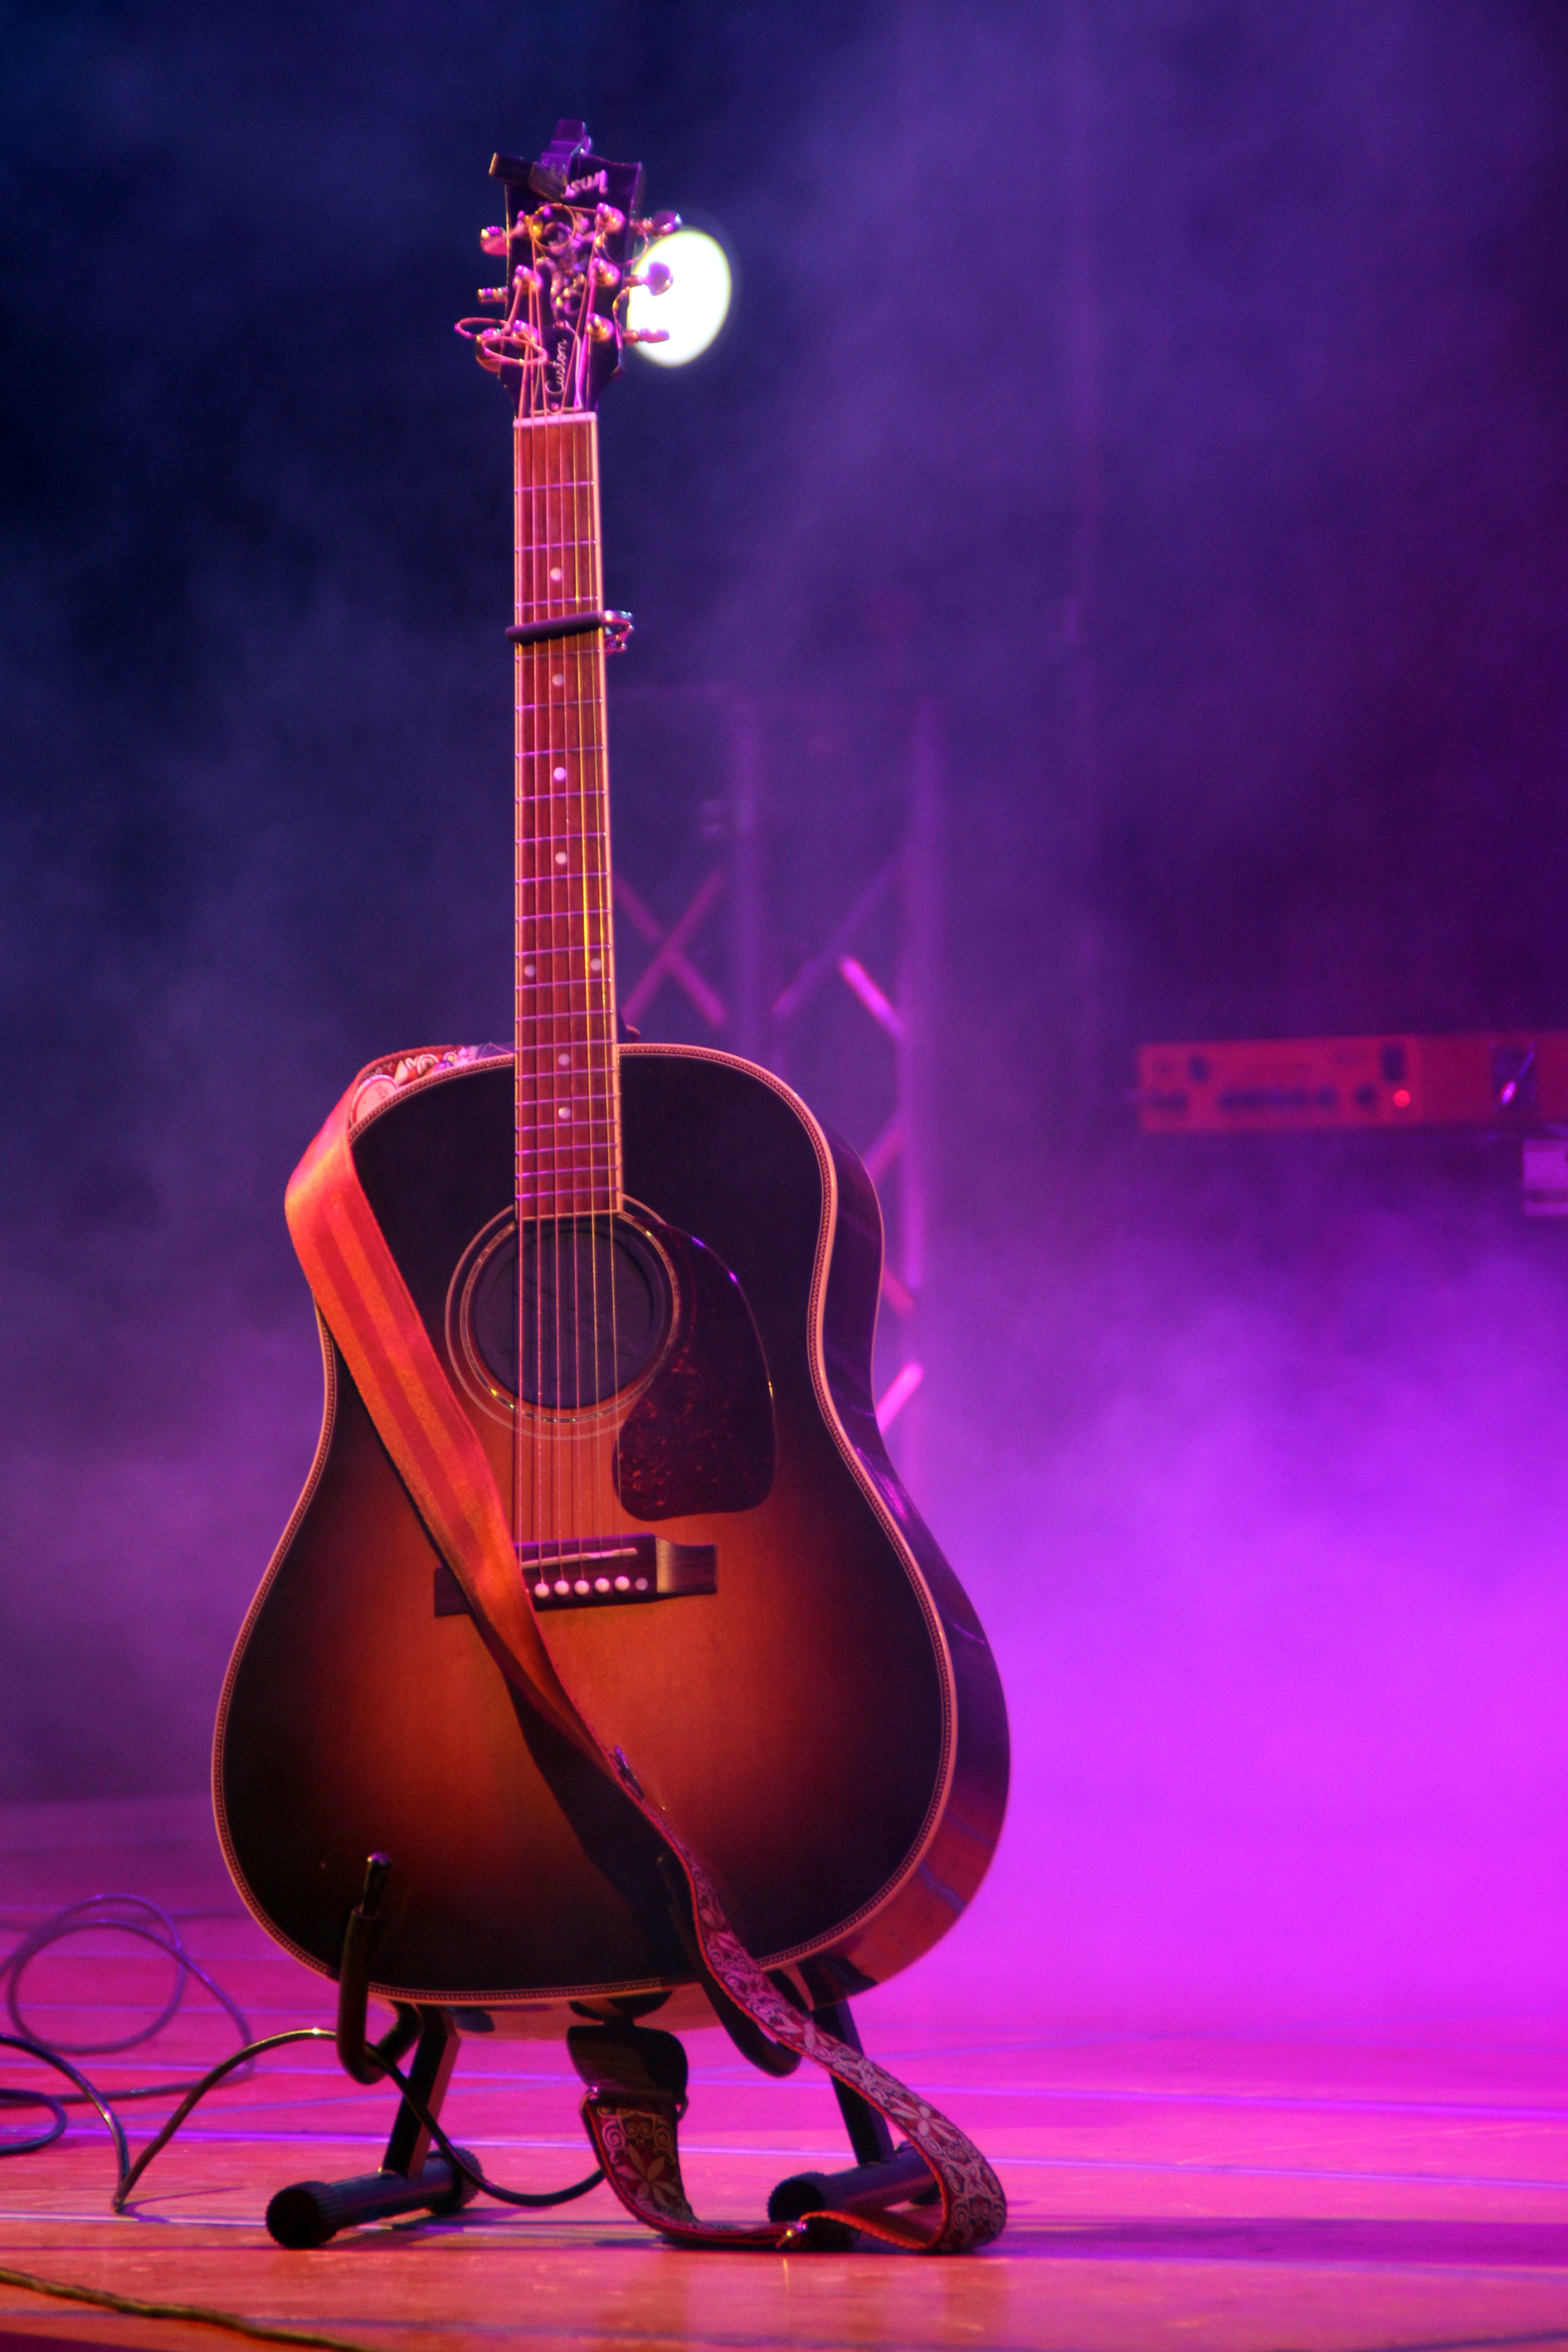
[0,0,1568,1999]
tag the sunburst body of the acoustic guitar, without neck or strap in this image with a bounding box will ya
[214,1047,1006,2034]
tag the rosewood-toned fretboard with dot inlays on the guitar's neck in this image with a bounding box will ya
[513,411,621,1219]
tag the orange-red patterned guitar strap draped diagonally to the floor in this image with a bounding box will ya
[285,1054,1006,2253]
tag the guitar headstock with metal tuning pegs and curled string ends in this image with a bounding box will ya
[459,122,679,416]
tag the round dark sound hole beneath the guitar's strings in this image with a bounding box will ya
[470,1219,672,1411]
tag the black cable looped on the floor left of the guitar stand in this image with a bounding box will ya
[0,1896,604,2213]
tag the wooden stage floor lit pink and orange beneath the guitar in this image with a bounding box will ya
[0,1799,1568,2352]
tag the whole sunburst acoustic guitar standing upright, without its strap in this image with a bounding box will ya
[214,124,1006,2034]
